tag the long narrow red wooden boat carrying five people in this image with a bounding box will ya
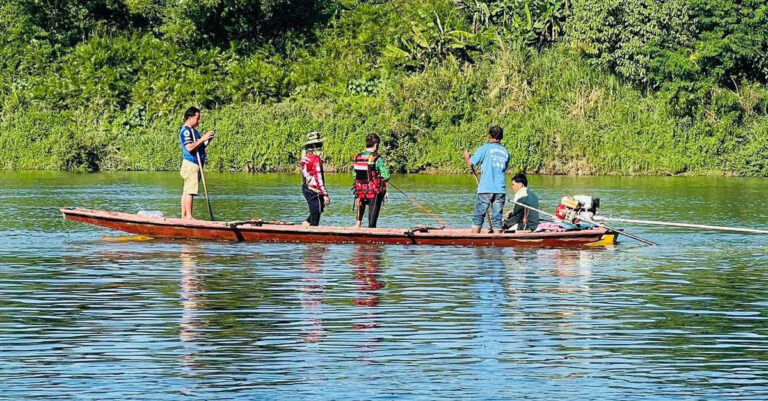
[60,208,617,247]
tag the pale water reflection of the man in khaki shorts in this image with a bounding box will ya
[179,239,205,369]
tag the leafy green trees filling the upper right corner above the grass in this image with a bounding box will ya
[569,0,768,118]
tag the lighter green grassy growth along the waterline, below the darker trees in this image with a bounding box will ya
[0,41,768,175]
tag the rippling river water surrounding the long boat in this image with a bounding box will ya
[0,172,768,400]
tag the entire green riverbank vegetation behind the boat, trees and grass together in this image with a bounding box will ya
[0,0,768,176]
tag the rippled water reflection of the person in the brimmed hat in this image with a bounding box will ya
[301,244,328,343]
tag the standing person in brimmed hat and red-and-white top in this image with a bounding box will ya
[301,131,331,227]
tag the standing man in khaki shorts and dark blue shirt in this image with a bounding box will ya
[179,107,215,219]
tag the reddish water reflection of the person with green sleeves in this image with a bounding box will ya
[352,245,383,329]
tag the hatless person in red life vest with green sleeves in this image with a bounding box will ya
[352,134,389,228]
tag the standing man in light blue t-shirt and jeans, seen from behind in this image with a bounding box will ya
[464,125,509,233]
